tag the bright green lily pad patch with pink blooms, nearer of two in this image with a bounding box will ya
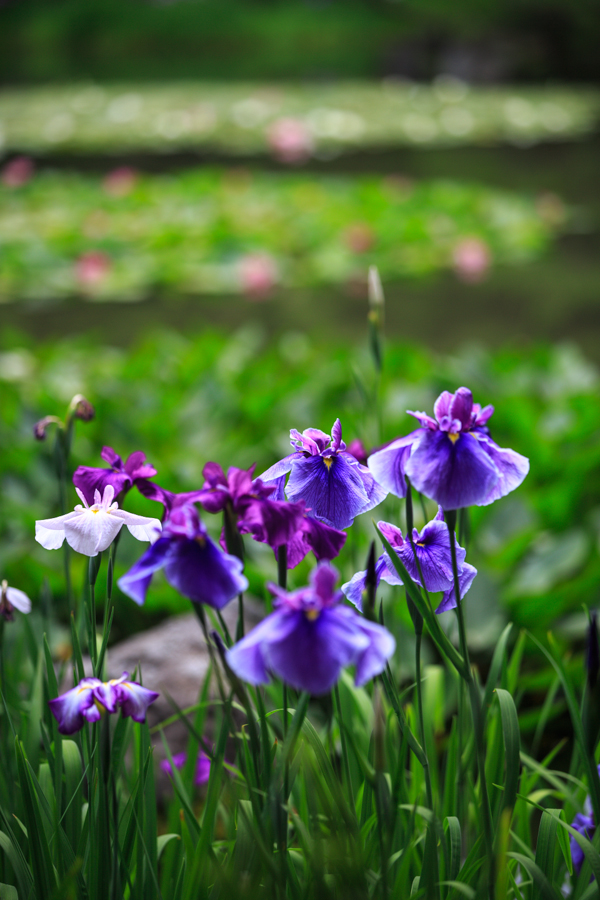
[0,169,566,301]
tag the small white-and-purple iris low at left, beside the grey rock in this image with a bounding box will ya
[48,672,159,734]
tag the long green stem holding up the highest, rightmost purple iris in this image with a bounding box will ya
[444,509,495,900]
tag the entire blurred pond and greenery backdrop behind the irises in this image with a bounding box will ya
[0,0,600,724]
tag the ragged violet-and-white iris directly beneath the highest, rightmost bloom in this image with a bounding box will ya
[342,510,477,613]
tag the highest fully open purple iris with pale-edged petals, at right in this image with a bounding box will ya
[368,387,529,510]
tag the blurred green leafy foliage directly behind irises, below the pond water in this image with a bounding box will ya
[0,326,600,651]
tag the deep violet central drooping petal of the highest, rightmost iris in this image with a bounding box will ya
[405,430,500,509]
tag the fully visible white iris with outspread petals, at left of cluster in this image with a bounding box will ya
[35,484,162,556]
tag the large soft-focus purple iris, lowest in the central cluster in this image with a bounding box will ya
[226,563,396,694]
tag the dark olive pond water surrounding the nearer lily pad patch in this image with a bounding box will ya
[0,137,600,362]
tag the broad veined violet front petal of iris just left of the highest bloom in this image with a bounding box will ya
[286,456,369,529]
